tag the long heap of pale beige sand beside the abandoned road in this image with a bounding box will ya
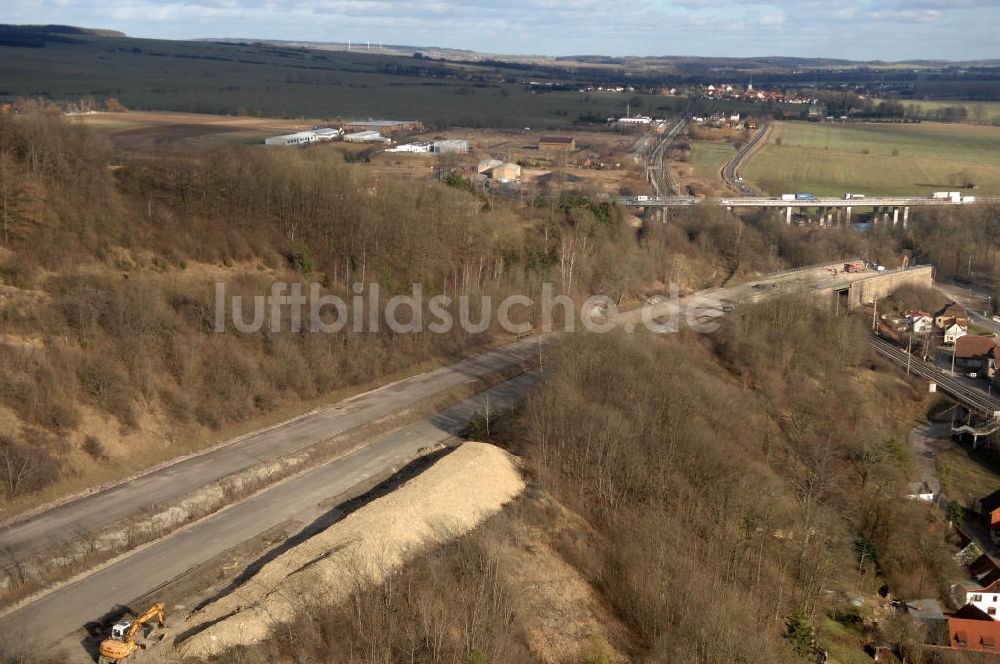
[180,443,524,657]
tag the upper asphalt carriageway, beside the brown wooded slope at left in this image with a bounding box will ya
[0,340,538,550]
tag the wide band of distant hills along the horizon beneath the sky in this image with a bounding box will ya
[0,25,1000,123]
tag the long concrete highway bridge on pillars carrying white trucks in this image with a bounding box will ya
[618,196,1000,226]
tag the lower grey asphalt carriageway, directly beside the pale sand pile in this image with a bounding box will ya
[0,373,538,658]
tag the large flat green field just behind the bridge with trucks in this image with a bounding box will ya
[744,122,1000,196]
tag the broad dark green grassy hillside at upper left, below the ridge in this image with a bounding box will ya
[0,30,682,127]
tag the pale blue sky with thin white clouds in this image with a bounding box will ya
[0,0,1000,60]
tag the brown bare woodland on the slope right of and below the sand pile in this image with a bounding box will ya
[197,300,957,664]
